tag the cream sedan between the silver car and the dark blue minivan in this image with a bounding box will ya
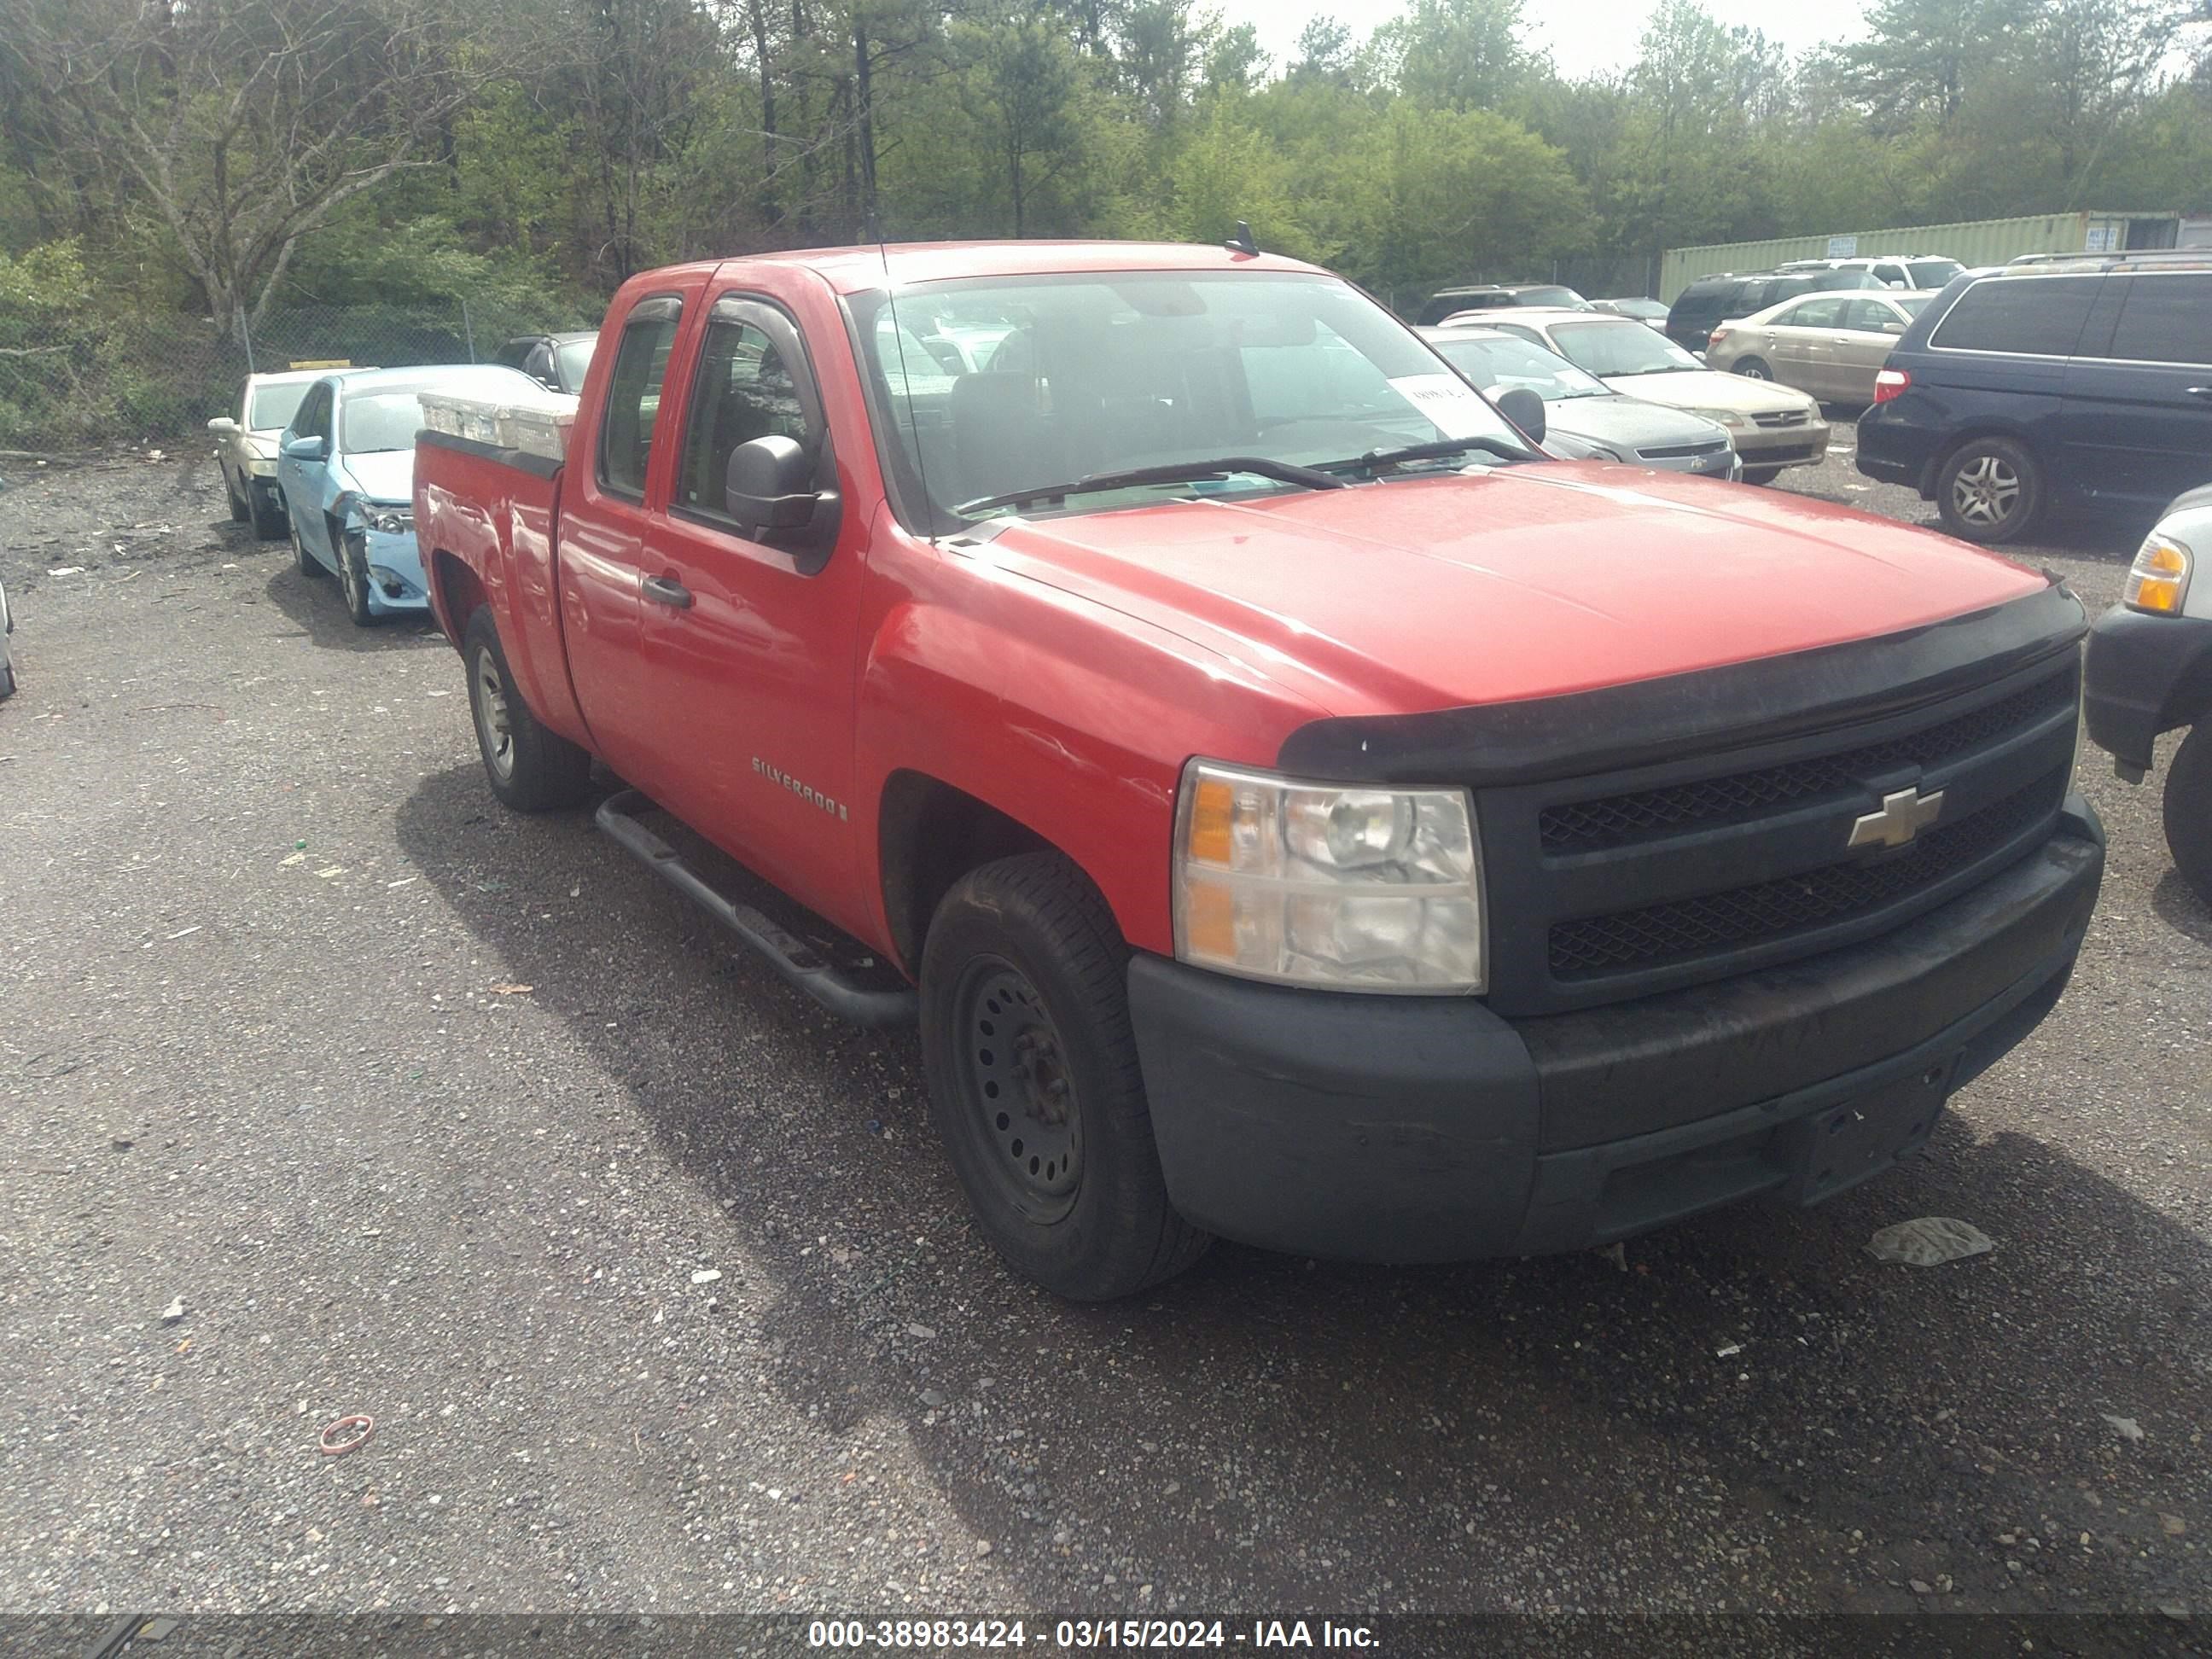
[1451,310,1827,485]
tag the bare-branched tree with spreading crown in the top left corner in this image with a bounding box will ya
[0,0,520,332]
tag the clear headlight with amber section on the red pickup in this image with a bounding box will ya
[1174,761,1484,993]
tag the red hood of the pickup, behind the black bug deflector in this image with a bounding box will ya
[978,463,2046,714]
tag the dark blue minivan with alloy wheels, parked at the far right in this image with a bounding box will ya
[1858,250,2212,542]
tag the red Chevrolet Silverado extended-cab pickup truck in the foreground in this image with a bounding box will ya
[416,243,2104,1299]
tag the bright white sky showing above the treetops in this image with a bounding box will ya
[1214,0,1871,78]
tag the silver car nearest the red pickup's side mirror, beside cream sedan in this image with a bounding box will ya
[1420,328,1743,478]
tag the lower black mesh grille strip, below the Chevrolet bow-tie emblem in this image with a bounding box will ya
[1551,772,2066,980]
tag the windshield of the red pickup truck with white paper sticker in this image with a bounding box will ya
[847,270,1528,531]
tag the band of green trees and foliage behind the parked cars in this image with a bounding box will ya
[0,0,2212,455]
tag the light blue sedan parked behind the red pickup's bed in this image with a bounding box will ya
[276,363,544,628]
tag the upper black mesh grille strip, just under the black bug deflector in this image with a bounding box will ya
[1537,670,2075,854]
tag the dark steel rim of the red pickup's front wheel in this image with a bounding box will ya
[953,956,1084,1221]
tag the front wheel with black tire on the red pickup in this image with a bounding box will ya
[923,852,1212,1303]
